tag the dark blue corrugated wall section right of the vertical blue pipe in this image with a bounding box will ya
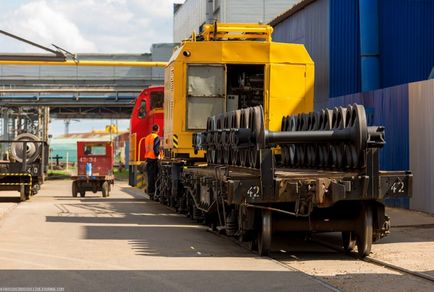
[379,0,434,87]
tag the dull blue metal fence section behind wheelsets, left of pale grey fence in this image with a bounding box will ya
[329,84,410,208]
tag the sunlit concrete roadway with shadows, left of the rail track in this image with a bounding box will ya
[0,181,332,291]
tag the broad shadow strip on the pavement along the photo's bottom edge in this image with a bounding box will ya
[0,270,330,291]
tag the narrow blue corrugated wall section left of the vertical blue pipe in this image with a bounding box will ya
[329,0,360,97]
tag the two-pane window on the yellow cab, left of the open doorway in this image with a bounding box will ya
[187,65,225,130]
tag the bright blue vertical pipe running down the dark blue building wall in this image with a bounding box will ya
[359,0,381,92]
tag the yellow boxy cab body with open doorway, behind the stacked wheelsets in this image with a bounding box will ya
[164,23,314,159]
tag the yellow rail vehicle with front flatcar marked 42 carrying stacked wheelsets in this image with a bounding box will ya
[154,24,412,257]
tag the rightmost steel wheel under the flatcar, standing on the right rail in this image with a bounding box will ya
[356,206,373,258]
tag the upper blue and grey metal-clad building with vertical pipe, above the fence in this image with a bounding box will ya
[271,0,434,107]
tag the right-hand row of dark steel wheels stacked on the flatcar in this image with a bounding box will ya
[281,105,368,169]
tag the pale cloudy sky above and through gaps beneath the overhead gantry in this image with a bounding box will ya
[0,0,176,136]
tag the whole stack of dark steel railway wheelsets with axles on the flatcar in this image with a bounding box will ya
[193,104,384,170]
